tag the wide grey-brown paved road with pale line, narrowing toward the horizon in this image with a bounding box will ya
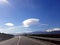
[0,36,56,45]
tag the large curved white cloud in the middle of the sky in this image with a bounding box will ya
[23,18,39,27]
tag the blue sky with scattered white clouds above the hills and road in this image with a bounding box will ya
[0,0,60,33]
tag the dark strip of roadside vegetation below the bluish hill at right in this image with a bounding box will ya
[25,34,60,38]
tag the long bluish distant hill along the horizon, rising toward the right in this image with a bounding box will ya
[15,31,60,36]
